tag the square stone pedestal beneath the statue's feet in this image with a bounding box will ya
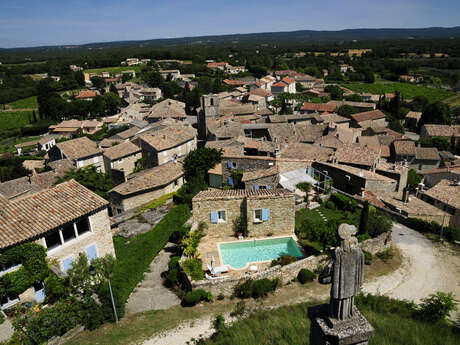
[308,304,375,345]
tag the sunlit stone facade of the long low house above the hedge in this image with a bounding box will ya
[109,177,184,214]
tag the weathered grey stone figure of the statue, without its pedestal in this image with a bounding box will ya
[319,224,364,320]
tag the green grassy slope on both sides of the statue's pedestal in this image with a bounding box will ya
[200,297,458,345]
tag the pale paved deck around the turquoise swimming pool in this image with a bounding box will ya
[198,231,297,276]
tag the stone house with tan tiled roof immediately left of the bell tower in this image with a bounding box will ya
[136,125,197,168]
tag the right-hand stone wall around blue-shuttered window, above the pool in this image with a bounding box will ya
[247,195,295,237]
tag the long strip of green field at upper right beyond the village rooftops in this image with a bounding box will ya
[342,83,455,102]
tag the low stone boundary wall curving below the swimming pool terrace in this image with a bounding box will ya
[187,233,391,296]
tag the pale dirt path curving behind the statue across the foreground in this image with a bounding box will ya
[142,224,460,345]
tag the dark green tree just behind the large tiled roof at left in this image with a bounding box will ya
[56,165,114,199]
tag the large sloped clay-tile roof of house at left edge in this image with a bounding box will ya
[0,180,108,248]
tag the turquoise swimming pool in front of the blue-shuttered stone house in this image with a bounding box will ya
[219,237,302,269]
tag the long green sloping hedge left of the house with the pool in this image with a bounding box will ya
[111,205,190,303]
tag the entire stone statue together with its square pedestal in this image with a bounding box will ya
[308,224,375,345]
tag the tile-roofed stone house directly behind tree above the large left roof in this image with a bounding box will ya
[48,137,105,172]
